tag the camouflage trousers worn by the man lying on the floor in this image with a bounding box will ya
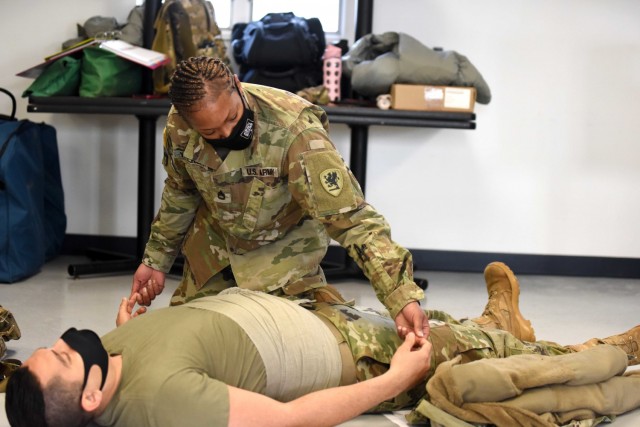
[312,304,571,412]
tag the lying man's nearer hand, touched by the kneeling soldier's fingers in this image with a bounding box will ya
[389,331,431,390]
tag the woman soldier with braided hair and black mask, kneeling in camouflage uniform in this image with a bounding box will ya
[132,57,428,337]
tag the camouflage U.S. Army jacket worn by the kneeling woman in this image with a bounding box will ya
[143,84,424,317]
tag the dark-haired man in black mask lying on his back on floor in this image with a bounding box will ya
[6,263,640,427]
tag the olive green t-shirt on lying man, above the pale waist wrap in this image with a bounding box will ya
[95,306,266,427]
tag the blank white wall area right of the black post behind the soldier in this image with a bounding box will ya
[367,0,640,258]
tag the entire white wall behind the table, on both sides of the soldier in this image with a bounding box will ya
[0,0,640,258]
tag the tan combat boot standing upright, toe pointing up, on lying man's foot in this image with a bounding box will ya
[471,262,536,342]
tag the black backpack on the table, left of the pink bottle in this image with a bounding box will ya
[231,12,326,92]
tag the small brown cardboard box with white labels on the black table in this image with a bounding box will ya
[391,84,476,113]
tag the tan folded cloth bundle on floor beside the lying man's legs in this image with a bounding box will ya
[417,345,640,427]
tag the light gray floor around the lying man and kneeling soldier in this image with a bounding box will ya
[0,257,640,427]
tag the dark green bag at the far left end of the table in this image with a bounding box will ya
[22,56,80,98]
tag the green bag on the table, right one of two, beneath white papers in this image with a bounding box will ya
[80,46,142,98]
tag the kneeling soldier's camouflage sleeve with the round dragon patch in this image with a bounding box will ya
[289,120,424,318]
